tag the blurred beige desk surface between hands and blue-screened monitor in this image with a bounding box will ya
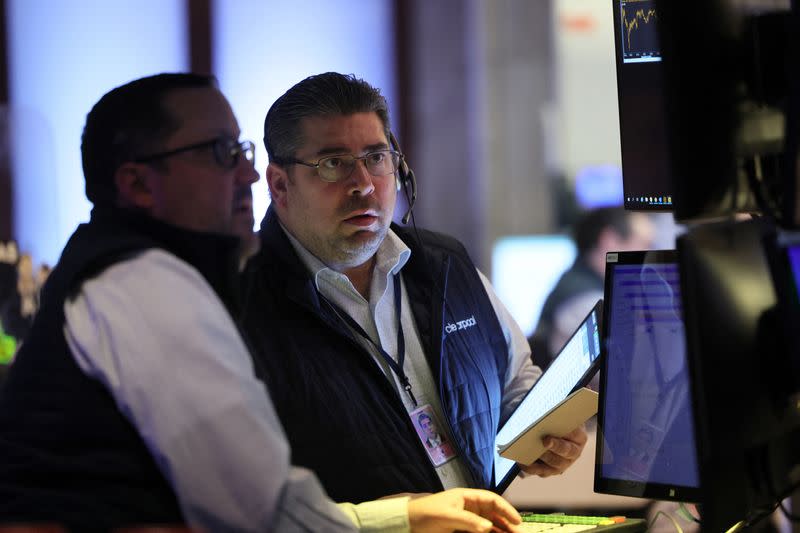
[503,428,649,510]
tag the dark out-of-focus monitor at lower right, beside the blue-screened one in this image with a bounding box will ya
[678,219,800,531]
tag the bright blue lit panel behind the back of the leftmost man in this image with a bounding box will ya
[6,0,186,265]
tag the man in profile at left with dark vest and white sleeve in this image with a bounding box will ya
[0,74,519,533]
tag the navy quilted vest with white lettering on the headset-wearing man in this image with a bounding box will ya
[241,208,508,502]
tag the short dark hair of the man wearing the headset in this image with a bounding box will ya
[264,72,390,164]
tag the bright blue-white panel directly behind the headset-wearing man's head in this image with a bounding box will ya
[212,0,397,226]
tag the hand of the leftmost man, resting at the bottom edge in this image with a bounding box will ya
[408,489,522,533]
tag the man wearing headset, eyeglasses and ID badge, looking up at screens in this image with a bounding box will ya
[240,72,587,501]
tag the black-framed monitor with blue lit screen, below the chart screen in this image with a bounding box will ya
[594,250,700,502]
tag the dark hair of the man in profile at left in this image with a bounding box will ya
[81,73,217,205]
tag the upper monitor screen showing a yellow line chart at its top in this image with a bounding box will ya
[612,0,673,211]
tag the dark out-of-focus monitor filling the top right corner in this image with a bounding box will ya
[652,0,800,225]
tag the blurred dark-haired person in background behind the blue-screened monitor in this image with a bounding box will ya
[528,207,656,369]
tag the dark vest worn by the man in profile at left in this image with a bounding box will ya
[0,208,236,531]
